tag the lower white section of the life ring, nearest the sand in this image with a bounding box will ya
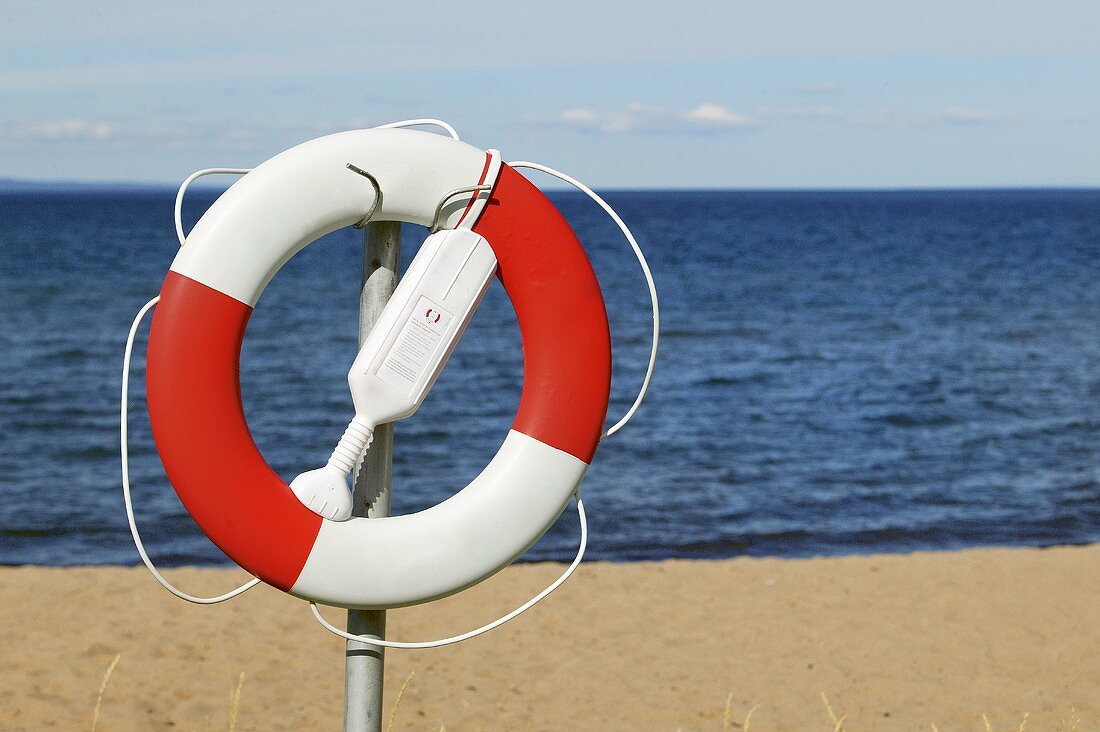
[290,430,589,608]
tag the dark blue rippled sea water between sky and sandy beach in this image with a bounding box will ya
[0,189,1100,565]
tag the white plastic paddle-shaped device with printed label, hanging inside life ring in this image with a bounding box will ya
[290,229,496,521]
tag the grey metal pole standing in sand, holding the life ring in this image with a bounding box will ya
[344,221,402,732]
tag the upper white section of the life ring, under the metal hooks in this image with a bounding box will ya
[172,129,487,305]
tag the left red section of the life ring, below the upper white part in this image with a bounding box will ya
[145,272,321,590]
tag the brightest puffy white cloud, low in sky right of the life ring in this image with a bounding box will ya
[528,102,760,134]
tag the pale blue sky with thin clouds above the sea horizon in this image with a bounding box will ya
[0,0,1100,188]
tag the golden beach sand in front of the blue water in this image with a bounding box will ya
[0,545,1100,732]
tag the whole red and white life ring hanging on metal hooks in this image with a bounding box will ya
[146,129,611,608]
